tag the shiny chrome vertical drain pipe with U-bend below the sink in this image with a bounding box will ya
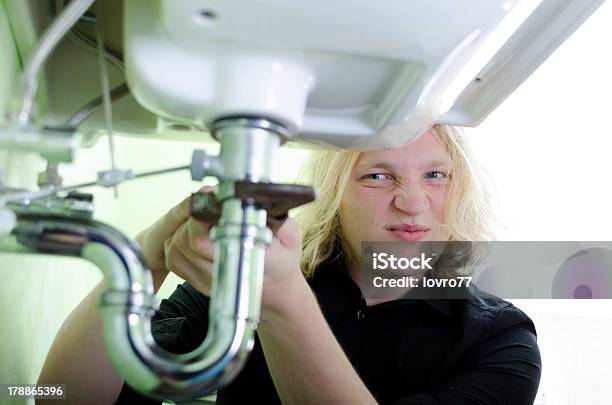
[103,118,286,400]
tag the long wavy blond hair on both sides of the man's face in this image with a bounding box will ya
[295,125,494,278]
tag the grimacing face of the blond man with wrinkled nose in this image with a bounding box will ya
[340,128,452,257]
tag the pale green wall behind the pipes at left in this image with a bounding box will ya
[0,137,306,403]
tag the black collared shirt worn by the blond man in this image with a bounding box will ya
[117,254,541,405]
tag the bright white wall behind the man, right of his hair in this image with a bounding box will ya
[467,1,612,405]
